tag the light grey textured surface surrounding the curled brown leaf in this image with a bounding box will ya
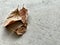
[0,0,60,45]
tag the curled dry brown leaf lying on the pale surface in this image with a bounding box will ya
[4,7,28,35]
